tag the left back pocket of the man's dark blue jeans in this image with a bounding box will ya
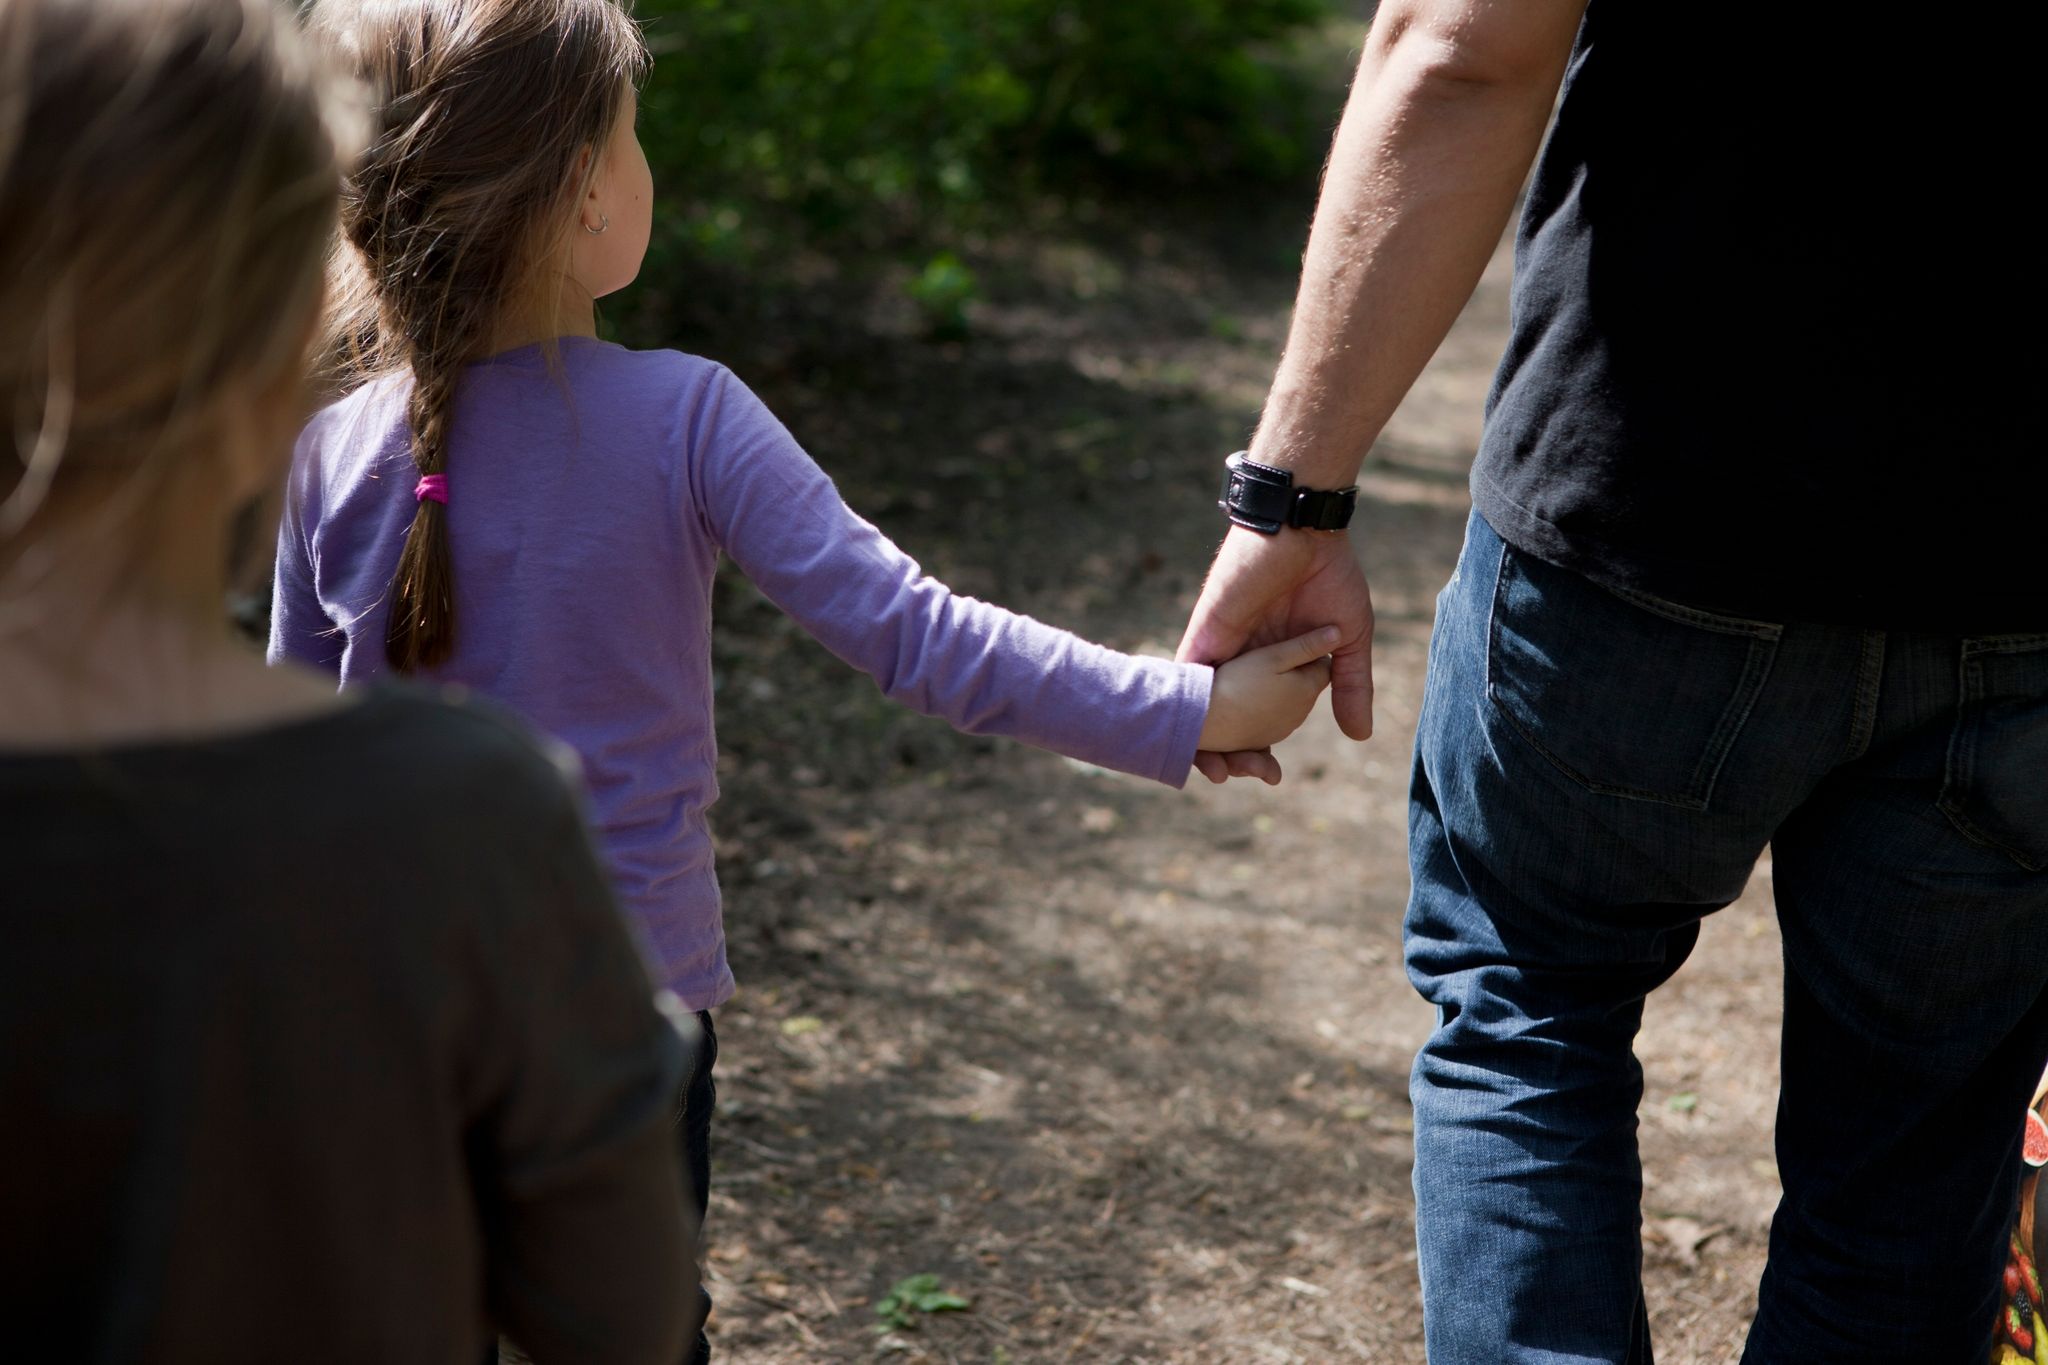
[1487,546,1784,810]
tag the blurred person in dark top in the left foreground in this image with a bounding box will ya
[0,0,692,1365]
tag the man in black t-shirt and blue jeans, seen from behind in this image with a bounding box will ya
[1182,0,2048,1365]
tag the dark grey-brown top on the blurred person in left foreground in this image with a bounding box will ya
[0,690,694,1365]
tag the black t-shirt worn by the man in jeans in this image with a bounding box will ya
[1473,0,2048,632]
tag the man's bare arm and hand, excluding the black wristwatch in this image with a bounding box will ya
[1180,0,1585,782]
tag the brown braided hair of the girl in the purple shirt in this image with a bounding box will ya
[311,0,647,673]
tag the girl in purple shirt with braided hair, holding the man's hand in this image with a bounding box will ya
[270,0,1331,1358]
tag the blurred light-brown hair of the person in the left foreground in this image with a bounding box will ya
[0,0,350,565]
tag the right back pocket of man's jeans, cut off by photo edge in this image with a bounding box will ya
[1939,634,2048,872]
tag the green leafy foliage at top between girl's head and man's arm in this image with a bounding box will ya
[637,0,1329,262]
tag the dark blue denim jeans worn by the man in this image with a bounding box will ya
[1407,516,2048,1365]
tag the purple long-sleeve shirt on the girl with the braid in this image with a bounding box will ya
[270,338,1212,1009]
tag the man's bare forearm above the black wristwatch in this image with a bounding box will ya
[1251,0,1583,487]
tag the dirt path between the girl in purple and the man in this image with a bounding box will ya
[696,122,1780,1365]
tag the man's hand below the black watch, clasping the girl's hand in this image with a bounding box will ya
[1176,526,1372,782]
